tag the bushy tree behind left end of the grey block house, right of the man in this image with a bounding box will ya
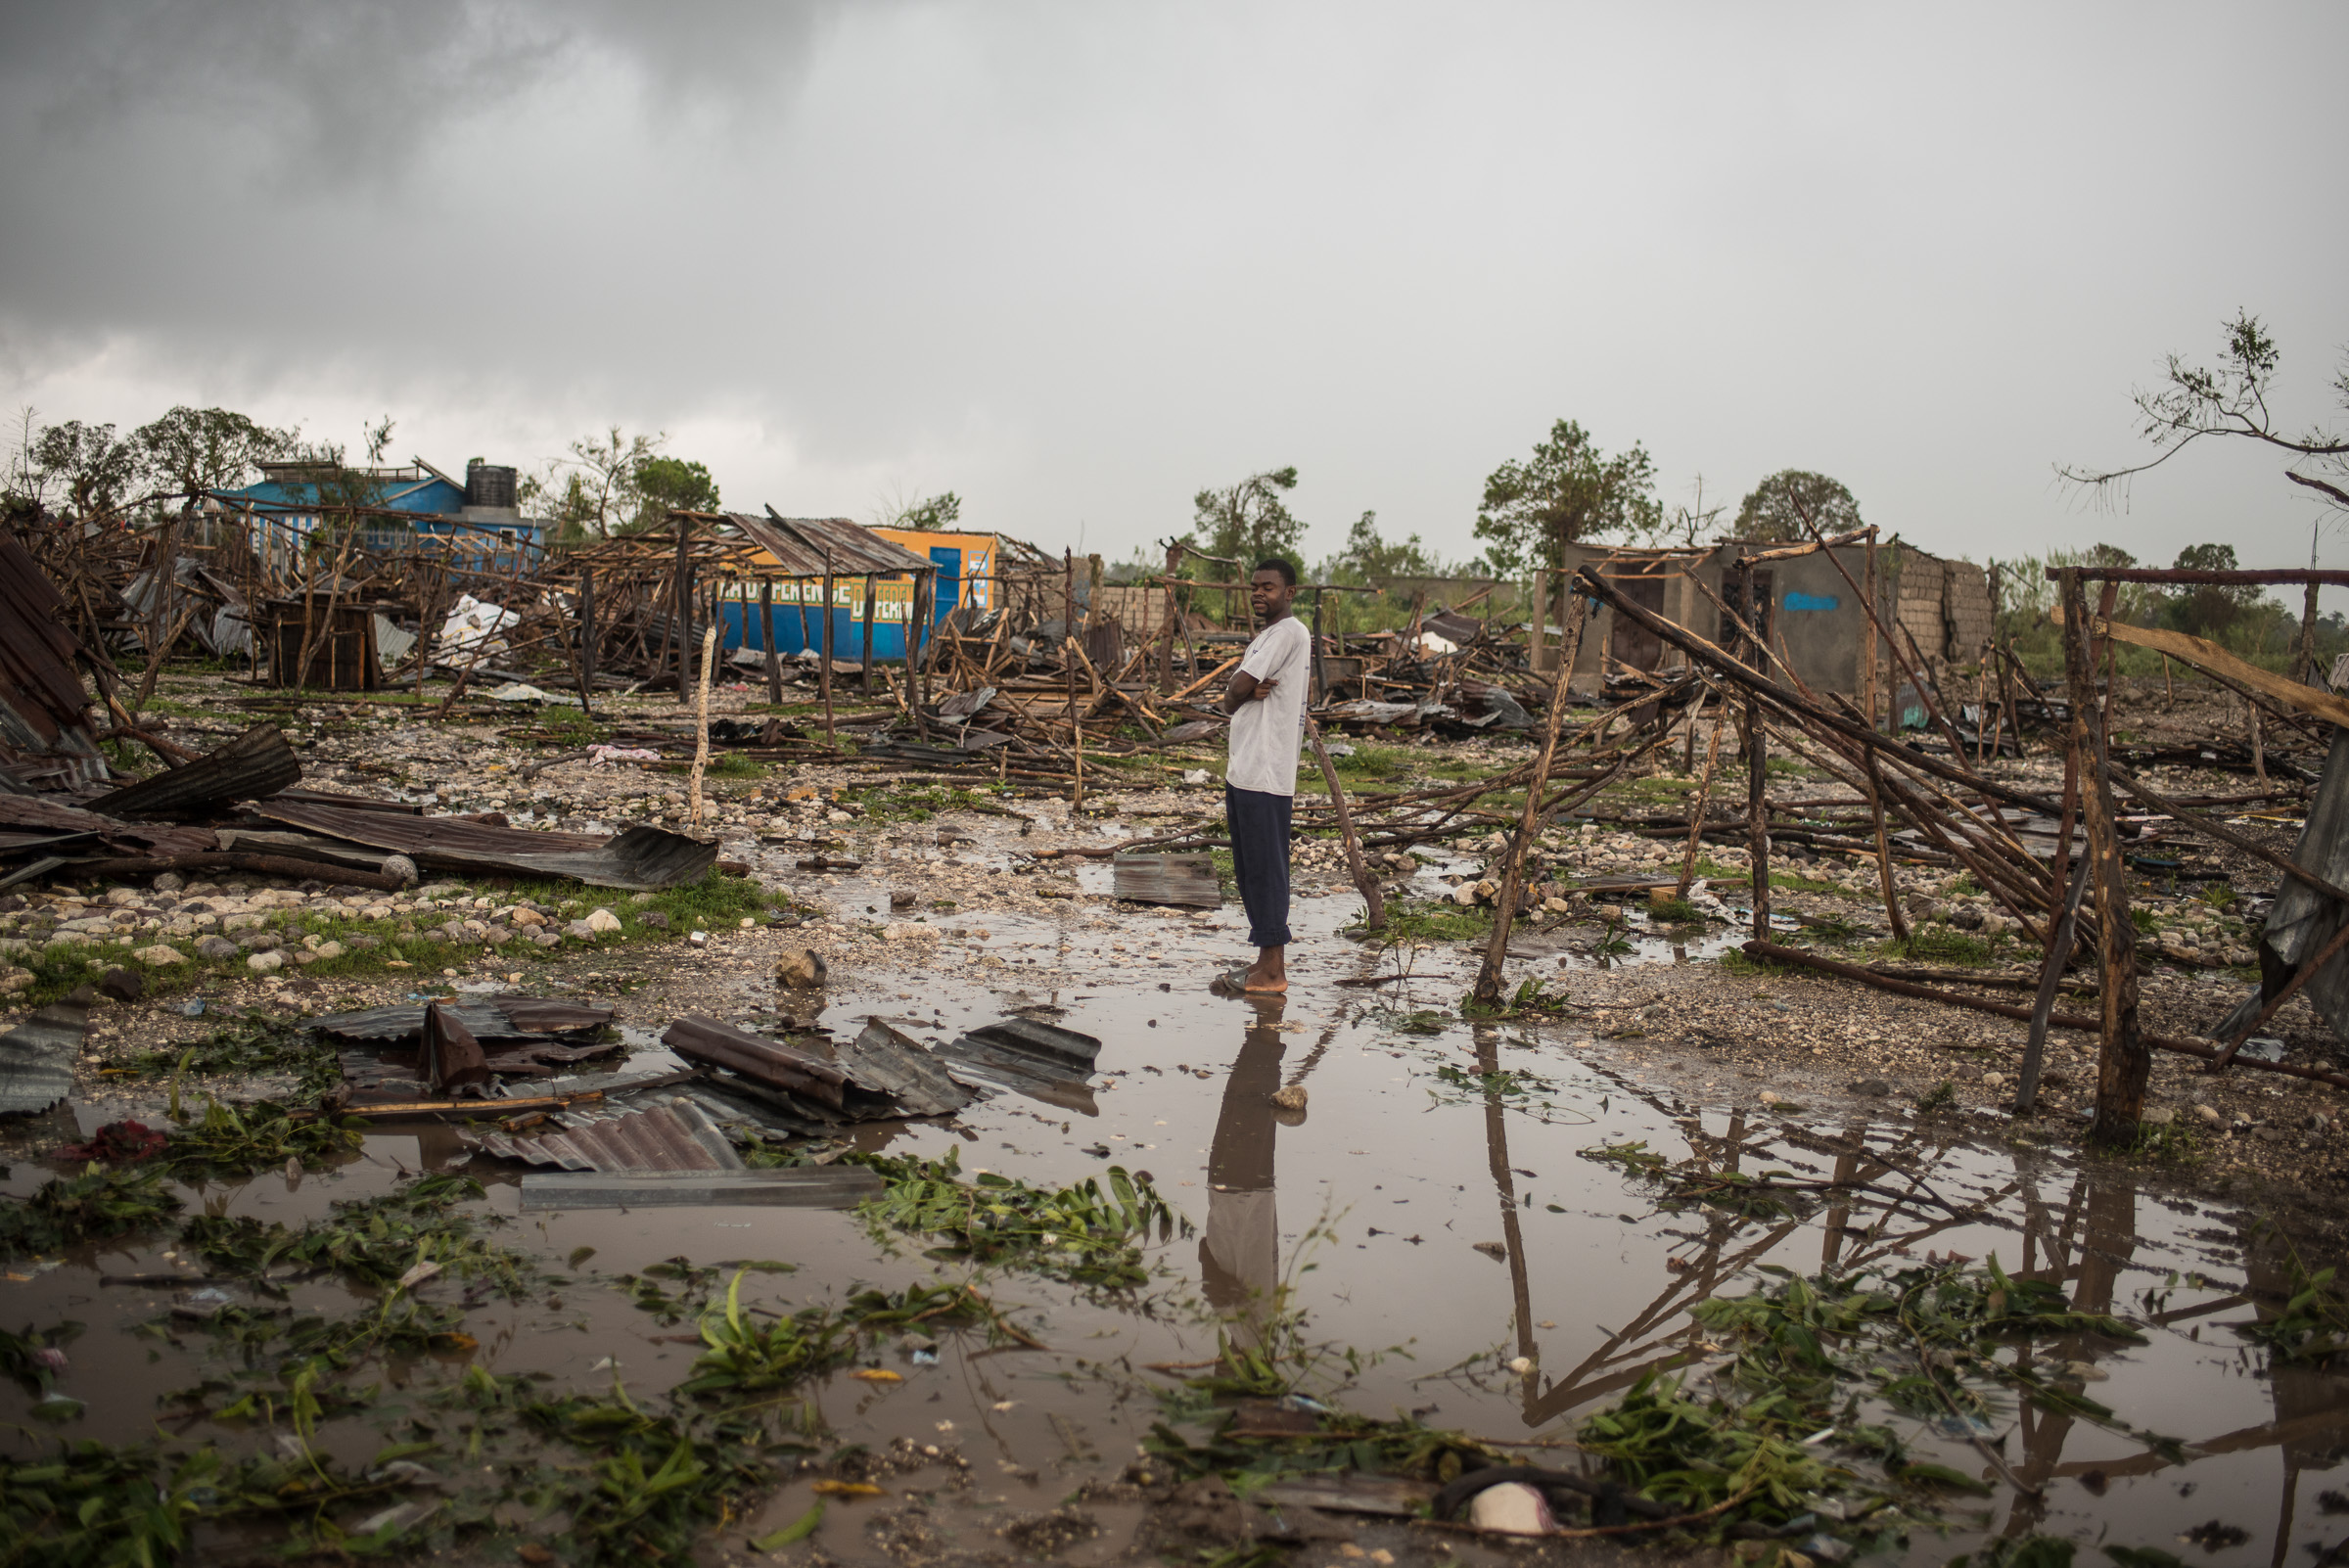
[1475,420,1663,577]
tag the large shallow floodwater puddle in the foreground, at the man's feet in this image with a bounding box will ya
[0,897,2349,1566]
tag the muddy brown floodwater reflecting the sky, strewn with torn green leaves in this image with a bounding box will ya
[0,871,2349,1563]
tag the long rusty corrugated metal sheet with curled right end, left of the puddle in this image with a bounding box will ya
[253,801,718,892]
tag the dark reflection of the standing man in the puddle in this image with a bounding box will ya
[1198,995,1304,1348]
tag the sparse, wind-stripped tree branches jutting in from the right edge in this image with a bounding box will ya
[2055,310,2349,566]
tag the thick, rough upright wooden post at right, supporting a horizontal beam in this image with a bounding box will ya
[2062,566,2154,1148]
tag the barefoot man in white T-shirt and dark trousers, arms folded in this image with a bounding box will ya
[1223,556,1313,995]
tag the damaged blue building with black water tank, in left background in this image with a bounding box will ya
[216,458,547,568]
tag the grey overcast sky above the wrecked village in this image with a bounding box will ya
[0,0,2349,581]
